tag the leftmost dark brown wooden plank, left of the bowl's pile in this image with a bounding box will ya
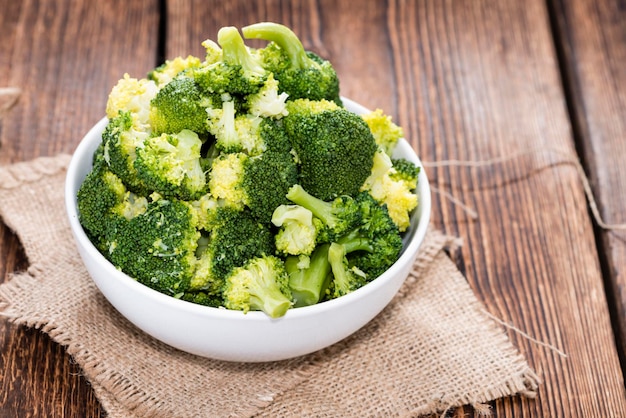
[0,0,159,418]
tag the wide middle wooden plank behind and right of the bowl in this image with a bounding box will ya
[166,0,626,417]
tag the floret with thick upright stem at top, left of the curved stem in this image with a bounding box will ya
[192,26,267,95]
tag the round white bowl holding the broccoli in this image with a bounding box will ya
[65,99,431,362]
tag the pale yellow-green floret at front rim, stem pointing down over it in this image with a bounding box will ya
[224,256,291,318]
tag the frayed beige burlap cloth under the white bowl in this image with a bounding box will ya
[0,155,539,417]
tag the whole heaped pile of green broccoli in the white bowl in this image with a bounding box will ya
[77,22,419,317]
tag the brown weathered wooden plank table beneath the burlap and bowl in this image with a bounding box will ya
[0,0,626,417]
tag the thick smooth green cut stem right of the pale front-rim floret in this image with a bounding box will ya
[285,244,332,307]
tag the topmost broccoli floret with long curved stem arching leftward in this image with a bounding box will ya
[242,22,341,105]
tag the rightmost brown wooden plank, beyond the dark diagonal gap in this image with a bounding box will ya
[553,0,626,367]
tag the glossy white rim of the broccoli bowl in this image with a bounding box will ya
[64,97,431,322]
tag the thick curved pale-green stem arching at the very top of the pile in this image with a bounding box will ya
[241,22,310,69]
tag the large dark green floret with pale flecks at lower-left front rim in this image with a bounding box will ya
[104,199,200,296]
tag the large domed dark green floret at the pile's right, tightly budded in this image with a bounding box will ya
[282,99,377,200]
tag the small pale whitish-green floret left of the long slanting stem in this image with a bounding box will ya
[272,205,317,255]
